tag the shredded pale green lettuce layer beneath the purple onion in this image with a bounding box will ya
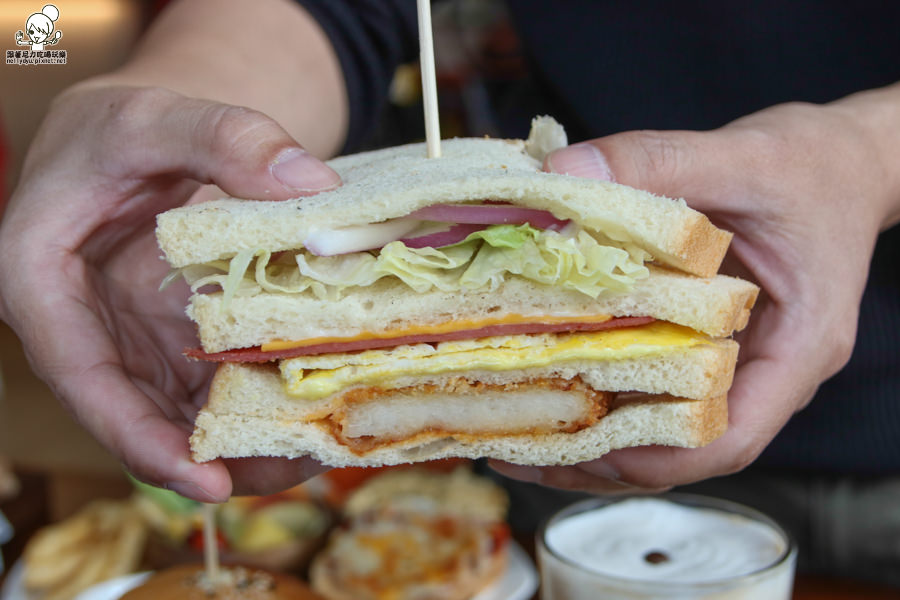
[183,224,650,306]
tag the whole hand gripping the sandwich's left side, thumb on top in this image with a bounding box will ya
[0,82,340,501]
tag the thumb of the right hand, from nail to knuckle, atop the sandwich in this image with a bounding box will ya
[544,131,711,196]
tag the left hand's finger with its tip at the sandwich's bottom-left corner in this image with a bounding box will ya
[17,292,231,502]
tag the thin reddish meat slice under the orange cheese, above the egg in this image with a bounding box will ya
[184,317,656,363]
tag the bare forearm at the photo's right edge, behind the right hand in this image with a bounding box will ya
[828,83,900,231]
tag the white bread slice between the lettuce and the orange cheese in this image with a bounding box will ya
[188,268,759,353]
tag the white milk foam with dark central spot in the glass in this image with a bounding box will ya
[545,498,788,583]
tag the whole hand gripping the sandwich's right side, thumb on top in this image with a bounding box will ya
[494,97,900,493]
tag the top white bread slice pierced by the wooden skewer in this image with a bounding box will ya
[156,138,731,277]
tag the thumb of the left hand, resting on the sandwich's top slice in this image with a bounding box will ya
[105,89,341,200]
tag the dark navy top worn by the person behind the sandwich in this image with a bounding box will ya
[299,0,900,475]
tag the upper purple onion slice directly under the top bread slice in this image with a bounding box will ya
[408,204,569,230]
